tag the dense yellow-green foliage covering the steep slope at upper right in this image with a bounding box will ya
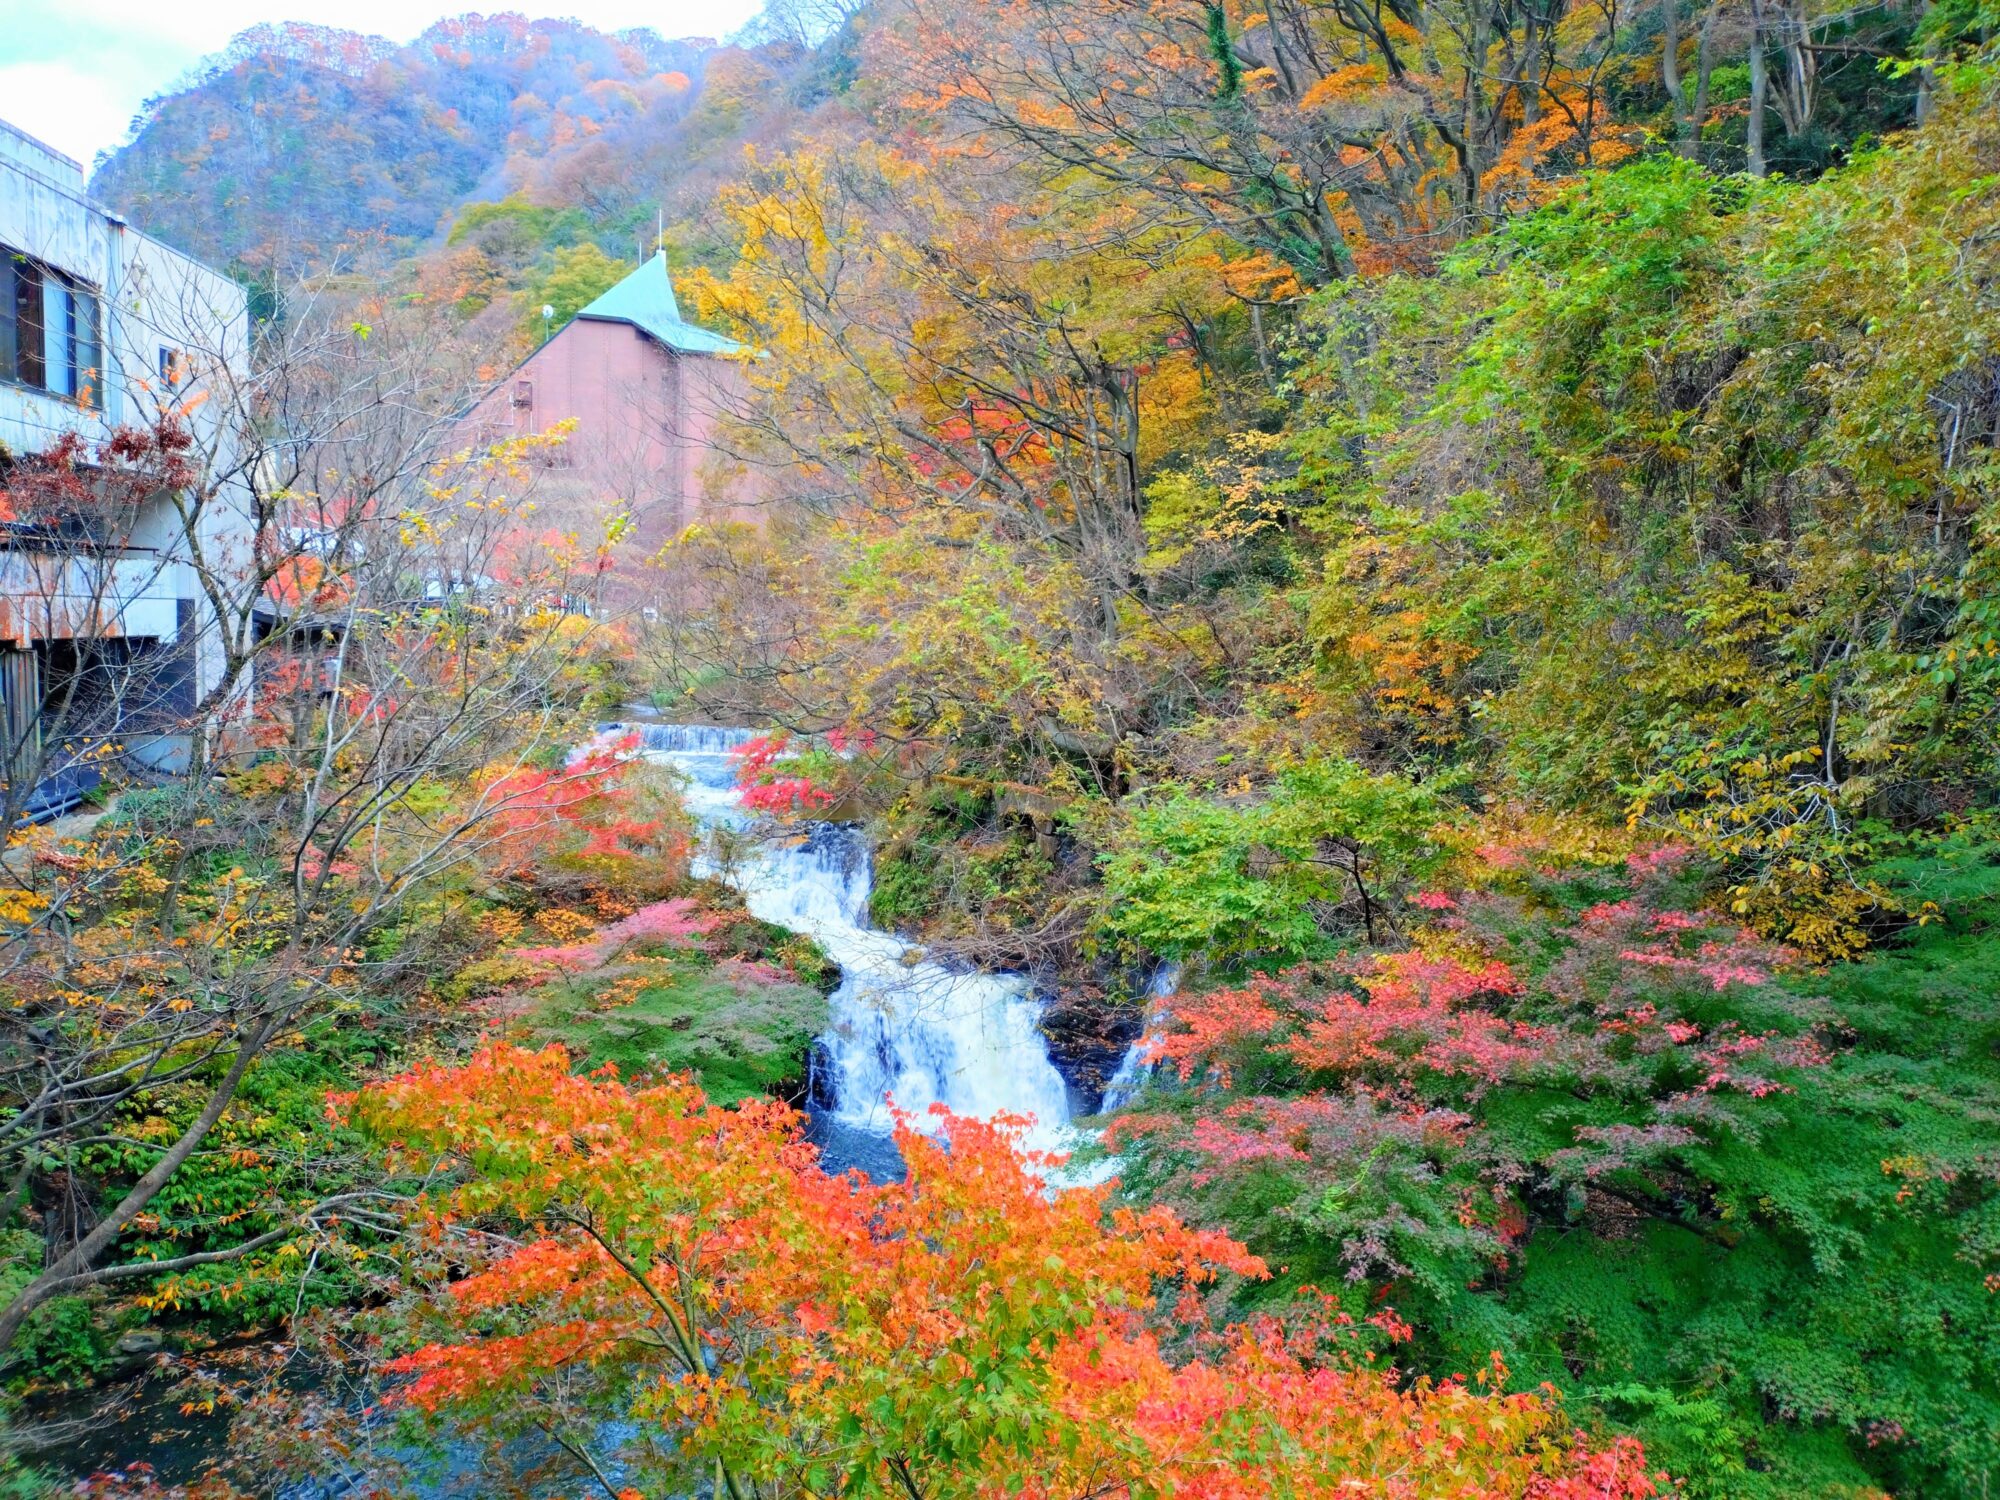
[1298,82,2000,954]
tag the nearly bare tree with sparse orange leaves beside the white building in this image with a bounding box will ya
[0,268,632,1344]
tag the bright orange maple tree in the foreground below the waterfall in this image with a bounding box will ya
[334,1046,1656,1500]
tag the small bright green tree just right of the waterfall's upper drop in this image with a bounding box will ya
[1102,758,1448,970]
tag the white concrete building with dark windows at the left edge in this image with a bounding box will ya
[0,122,254,814]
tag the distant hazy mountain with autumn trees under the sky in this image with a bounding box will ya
[92,14,780,272]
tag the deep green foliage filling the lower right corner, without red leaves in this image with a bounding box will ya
[1504,892,2000,1496]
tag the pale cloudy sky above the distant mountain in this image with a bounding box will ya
[0,0,760,170]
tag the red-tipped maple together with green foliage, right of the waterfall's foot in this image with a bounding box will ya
[1122,864,2000,1500]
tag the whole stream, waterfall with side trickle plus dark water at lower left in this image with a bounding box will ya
[36,722,1146,1500]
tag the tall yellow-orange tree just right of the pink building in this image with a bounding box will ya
[680,142,1210,778]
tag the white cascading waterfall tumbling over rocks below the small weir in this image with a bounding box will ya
[626,724,1070,1154]
